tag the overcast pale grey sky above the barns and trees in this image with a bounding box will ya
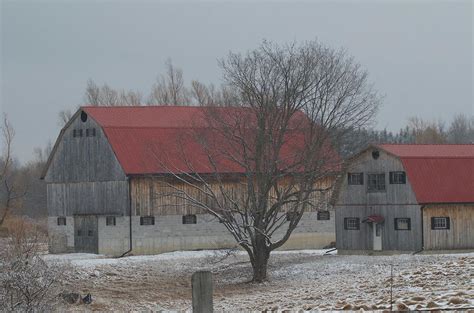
[0,0,474,161]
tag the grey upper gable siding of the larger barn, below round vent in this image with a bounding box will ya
[45,114,126,183]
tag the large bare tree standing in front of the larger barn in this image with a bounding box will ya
[157,41,379,282]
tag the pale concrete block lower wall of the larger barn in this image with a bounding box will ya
[94,212,335,256]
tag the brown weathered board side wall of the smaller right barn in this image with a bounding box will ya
[423,204,474,250]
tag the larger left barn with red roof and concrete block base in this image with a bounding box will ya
[43,106,335,255]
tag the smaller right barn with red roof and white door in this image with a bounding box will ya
[336,144,474,253]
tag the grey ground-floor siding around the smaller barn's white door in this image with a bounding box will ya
[336,205,422,251]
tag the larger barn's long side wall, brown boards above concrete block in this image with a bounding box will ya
[93,177,335,255]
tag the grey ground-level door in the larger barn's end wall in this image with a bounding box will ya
[74,215,99,253]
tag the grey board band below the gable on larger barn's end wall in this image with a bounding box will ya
[47,181,129,216]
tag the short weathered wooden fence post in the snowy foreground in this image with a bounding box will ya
[191,271,214,313]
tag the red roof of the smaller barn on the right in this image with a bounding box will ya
[378,144,474,203]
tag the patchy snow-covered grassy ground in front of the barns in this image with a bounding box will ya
[45,250,474,311]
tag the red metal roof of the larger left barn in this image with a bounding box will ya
[82,106,339,175]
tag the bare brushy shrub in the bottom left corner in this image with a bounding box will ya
[0,219,65,312]
